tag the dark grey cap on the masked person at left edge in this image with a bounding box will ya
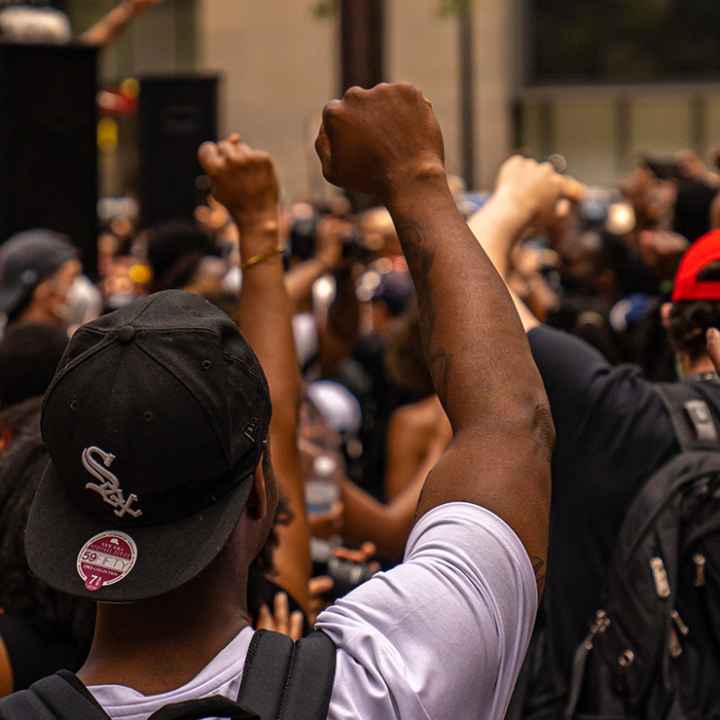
[0,230,78,314]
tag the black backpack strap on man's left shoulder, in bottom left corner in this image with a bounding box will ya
[0,671,110,720]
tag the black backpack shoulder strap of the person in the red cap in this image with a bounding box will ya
[655,383,720,452]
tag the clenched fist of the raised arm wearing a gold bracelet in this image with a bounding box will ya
[198,135,279,227]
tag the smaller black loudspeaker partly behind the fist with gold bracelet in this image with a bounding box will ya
[140,75,219,227]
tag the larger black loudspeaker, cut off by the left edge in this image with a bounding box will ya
[0,43,98,274]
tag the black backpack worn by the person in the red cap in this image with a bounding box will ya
[565,379,720,720]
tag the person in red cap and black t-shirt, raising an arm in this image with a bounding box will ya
[470,205,720,717]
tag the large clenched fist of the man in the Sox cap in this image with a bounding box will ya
[315,83,444,201]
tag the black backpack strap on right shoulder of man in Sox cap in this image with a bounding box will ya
[238,630,336,720]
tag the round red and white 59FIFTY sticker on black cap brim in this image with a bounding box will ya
[77,530,137,592]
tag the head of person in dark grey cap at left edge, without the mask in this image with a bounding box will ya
[0,230,82,328]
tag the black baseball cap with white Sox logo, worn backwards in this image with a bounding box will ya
[25,290,271,602]
